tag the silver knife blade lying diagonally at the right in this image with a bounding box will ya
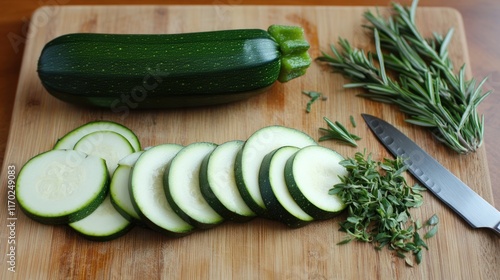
[362,114,500,236]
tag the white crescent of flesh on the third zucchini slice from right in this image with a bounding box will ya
[236,125,317,214]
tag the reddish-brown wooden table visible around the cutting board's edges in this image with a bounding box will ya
[0,0,500,278]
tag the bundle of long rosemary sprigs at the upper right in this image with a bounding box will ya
[317,0,491,154]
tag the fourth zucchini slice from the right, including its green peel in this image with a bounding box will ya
[200,140,255,222]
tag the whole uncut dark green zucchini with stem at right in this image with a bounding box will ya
[38,25,311,111]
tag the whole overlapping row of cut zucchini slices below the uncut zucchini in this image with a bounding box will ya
[16,121,347,241]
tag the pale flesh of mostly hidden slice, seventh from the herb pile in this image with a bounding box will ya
[109,151,143,221]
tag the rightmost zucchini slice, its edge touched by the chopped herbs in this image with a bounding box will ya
[285,146,348,219]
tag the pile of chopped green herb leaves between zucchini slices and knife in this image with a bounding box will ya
[329,152,437,265]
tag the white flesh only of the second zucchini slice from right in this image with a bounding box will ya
[261,146,313,223]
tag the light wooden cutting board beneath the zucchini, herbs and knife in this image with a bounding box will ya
[0,6,500,279]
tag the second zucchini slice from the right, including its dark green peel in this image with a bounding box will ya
[259,146,314,228]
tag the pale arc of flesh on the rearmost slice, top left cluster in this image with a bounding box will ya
[54,121,141,152]
